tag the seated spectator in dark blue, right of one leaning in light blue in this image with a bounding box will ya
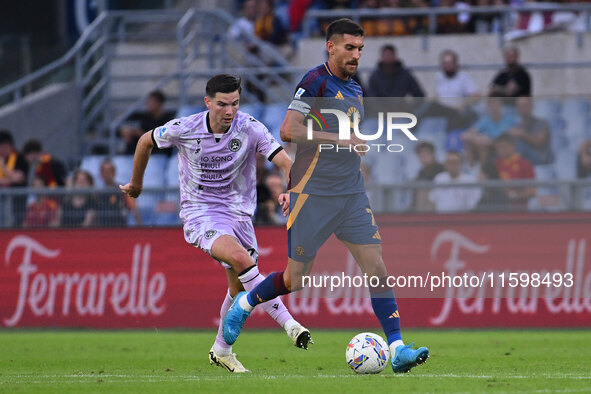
[509,97,554,166]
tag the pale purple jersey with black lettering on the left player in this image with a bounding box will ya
[152,111,282,223]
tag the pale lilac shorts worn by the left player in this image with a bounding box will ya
[183,218,258,268]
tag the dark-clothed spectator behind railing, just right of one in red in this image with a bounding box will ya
[61,170,97,227]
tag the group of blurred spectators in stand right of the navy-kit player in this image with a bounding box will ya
[364,45,591,212]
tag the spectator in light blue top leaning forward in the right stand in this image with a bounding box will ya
[461,97,516,168]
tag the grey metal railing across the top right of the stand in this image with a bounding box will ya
[302,3,591,40]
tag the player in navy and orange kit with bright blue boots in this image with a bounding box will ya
[223,19,429,373]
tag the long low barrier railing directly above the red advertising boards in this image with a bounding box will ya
[0,179,591,228]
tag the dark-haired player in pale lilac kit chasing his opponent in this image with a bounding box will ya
[120,74,311,372]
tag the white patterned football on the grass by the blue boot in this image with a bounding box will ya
[345,332,390,374]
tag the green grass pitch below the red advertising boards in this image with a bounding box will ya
[0,330,591,394]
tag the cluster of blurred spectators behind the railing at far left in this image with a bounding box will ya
[0,130,141,227]
